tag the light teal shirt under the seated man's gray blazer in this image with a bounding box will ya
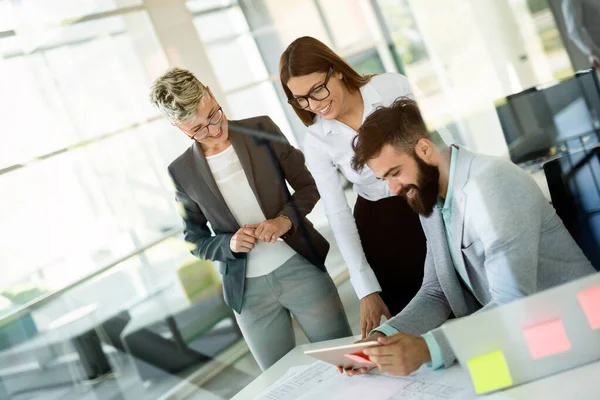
[371,147,462,369]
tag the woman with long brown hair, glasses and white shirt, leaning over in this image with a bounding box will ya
[280,36,426,337]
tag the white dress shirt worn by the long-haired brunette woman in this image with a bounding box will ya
[304,73,413,299]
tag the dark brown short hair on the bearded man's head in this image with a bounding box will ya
[352,97,431,171]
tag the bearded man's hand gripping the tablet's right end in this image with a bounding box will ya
[364,332,431,375]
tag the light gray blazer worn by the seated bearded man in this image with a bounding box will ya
[386,148,595,367]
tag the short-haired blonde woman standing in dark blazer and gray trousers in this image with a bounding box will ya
[150,68,351,370]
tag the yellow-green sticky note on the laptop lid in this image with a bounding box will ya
[467,350,512,394]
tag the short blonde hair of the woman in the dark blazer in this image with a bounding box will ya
[150,67,207,124]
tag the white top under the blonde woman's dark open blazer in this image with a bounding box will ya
[206,146,296,278]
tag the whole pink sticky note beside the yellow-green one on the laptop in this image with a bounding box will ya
[523,319,571,360]
